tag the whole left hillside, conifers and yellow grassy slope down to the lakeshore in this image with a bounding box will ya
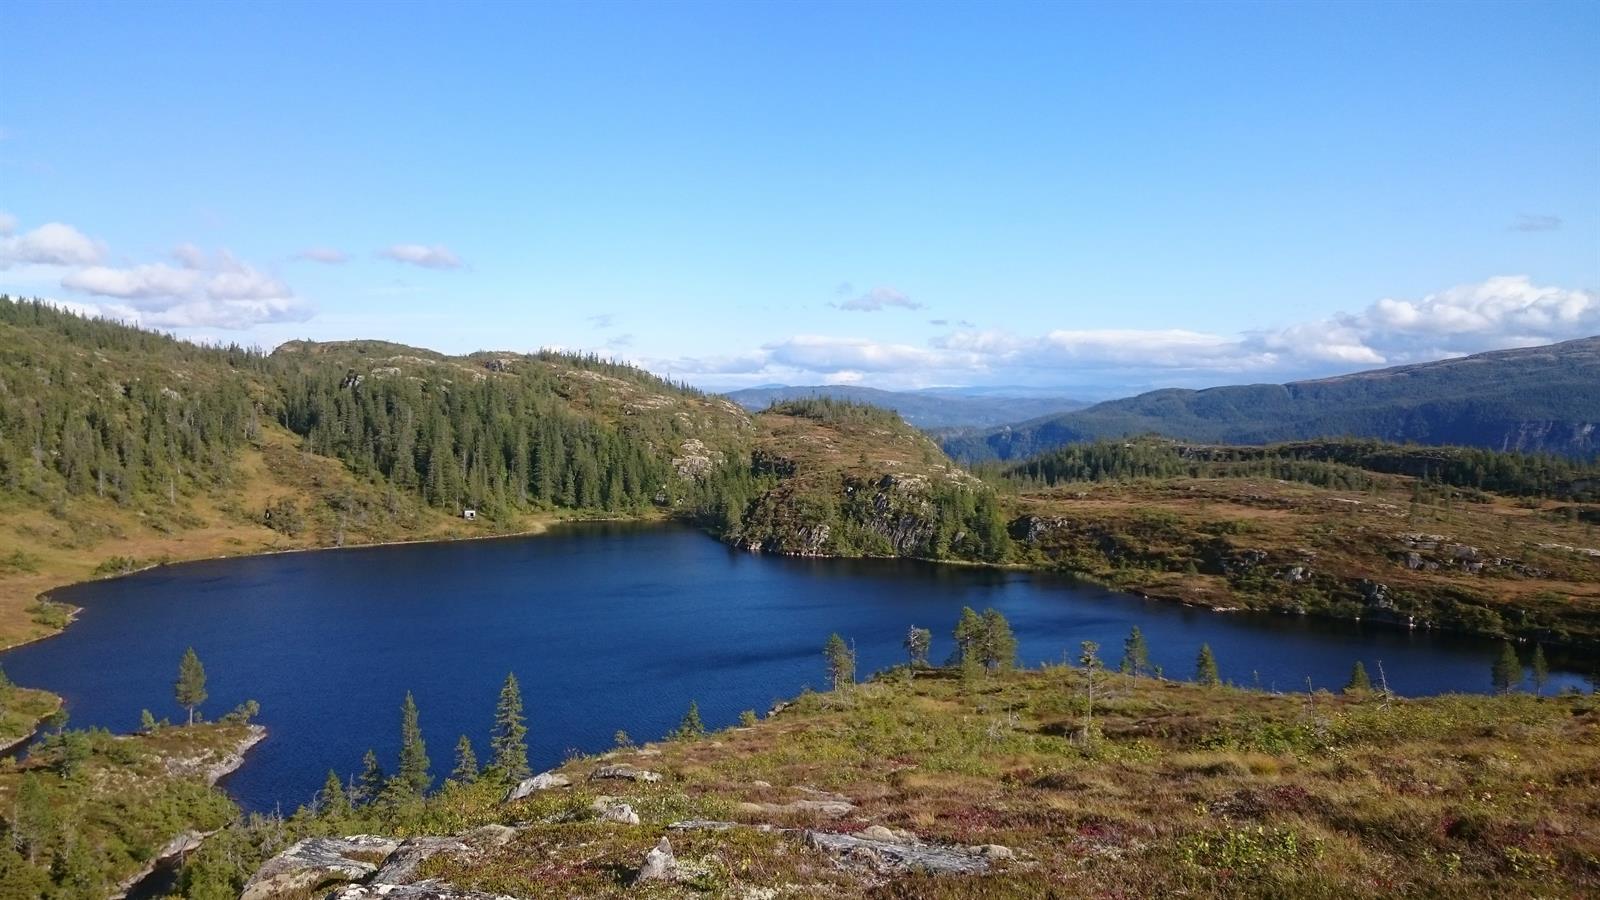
[0,298,1006,642]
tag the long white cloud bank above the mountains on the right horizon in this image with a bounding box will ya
[656,275,1600,386]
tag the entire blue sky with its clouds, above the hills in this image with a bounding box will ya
[0,2,1600,396]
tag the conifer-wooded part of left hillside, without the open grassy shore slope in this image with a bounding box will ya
[0,298,1006,559]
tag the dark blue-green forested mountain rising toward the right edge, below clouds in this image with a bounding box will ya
[942,336,1600,461]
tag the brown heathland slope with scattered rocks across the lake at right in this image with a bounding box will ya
[1014,476,1600,649]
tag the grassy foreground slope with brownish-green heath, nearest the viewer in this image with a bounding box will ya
[212,668,1600,898]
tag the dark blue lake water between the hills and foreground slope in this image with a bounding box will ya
[0,525,1579,812]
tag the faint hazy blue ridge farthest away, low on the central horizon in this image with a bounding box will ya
[723,384,1088,429]
